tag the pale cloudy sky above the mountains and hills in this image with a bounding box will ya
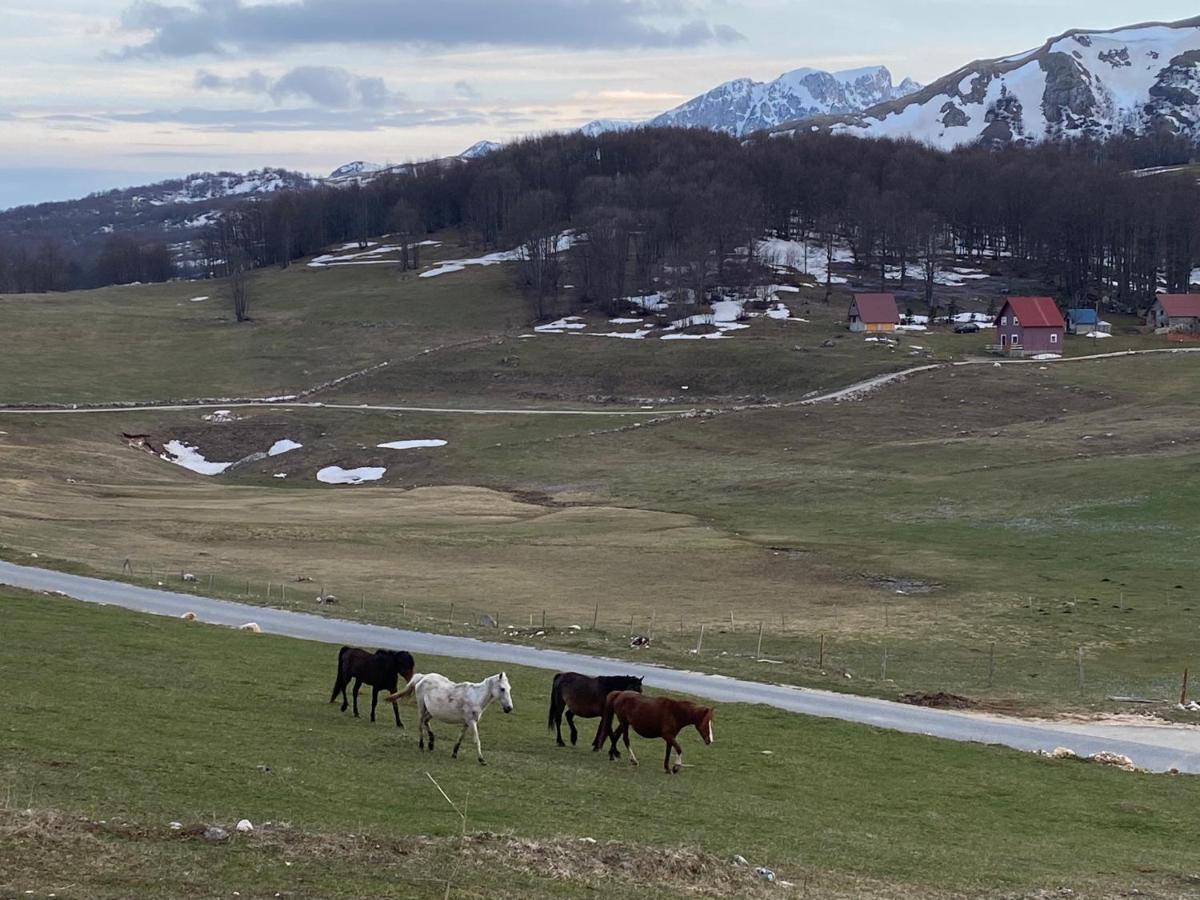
[0,0,1195,209]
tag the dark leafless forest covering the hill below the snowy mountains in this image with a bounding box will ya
[0,128,1200,314]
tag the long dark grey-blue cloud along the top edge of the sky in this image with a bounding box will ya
[118,0,743,56]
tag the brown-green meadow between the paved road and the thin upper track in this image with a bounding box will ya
[0,354,1200,710]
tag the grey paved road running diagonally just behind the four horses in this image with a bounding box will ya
[0,562,1200,774]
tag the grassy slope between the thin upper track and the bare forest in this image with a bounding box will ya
[0,240,936,406]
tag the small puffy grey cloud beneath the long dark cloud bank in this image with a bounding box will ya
[193,66,406,109]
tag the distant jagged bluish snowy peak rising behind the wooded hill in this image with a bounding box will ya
[580,66,922,137]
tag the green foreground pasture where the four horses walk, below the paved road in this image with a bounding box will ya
[0,592,1200,898]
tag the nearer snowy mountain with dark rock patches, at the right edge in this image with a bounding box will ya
[788,17,1200,148]
